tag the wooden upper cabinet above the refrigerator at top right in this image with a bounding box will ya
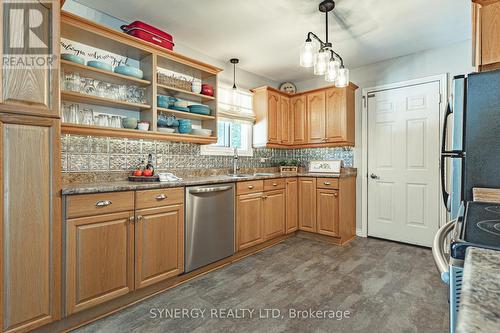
[472,0,500,71]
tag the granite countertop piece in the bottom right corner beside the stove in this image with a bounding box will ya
[456,247,500,333]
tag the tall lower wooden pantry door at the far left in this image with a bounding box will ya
[0,113,61,332]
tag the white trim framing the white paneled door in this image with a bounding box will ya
[358,73,449,237]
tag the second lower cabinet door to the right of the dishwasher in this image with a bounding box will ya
[263,190,286,240]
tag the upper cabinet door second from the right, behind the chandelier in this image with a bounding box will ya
[307,90,326,143]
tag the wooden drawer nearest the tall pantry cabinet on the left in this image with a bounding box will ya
[66,191,134,218]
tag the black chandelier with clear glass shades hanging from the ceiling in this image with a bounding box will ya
[300,0,349,88]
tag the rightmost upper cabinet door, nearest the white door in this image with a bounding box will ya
[325,88,346,142]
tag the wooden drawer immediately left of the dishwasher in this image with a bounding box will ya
[135,187,184,209]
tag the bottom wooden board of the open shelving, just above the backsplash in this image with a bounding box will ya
[61,123,217,144]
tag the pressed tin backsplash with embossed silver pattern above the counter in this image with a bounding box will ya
[62,135,353,172]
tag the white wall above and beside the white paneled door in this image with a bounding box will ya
[296,40,473,229]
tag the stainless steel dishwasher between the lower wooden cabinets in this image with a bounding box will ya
[184,183,235,272]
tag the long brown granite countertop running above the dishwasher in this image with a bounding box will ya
[62,168,357,195]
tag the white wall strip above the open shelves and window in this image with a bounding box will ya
[63,0,279,89]
